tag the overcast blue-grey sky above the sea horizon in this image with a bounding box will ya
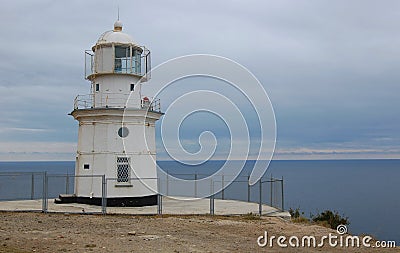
[0,0,400,160]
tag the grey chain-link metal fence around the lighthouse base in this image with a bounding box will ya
[0,172,284,214]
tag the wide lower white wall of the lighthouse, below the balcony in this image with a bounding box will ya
[73,109,161,197]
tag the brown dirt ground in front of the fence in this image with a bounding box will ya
[0,212,400,252]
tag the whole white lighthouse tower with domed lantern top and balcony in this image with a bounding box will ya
[61,20,162,206]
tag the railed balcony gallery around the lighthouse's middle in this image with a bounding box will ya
[74,93,161,113]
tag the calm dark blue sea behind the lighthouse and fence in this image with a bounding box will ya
[0,159,400,245]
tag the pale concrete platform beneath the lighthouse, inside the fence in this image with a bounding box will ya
[0,197,290,218]
